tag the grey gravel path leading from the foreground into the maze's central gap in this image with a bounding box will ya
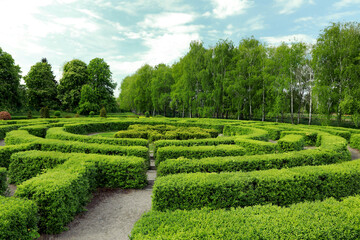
[39,143,156,240]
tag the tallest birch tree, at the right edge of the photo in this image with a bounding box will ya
[313,23,360,124]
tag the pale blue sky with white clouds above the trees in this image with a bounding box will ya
[0,0,360,94]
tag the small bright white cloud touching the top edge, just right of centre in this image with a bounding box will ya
[211,0,254,19]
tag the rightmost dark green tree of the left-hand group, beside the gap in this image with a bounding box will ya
[87,58,116,111]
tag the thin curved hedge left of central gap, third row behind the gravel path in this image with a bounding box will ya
[46,127,148,147]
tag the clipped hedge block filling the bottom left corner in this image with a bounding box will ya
[0,196,40,240]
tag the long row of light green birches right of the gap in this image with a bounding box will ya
[118,22,360,125]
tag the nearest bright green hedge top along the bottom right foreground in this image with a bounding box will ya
[130,196,360,240]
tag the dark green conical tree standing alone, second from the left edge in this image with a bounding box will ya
[24,58,59,109]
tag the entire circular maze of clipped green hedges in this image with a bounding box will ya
[0,118,360,239]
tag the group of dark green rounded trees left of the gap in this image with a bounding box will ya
[0,54,118,115]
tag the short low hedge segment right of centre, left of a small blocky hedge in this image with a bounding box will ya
[235,138,278,155]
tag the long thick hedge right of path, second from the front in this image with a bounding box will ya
[152,160,360,211]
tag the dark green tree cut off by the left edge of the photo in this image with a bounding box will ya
[0,48,21,110]
